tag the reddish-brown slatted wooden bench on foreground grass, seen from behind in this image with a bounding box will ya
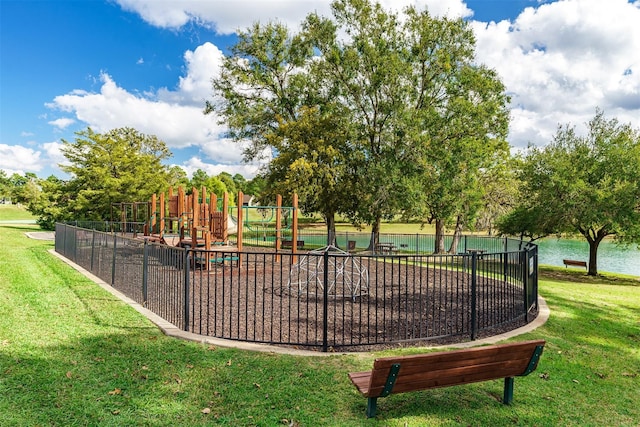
[349,340,545,418]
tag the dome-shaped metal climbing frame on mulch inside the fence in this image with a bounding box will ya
[287,245,369,302]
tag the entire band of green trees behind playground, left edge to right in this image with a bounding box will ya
[0,0,640,274]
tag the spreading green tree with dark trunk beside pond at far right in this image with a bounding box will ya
[500,111,640,275]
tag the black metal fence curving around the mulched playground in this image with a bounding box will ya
[55,224,538,351]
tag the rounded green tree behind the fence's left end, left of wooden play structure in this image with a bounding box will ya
[29,128,171,226]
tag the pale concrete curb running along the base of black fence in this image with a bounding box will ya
[49,249,550,356]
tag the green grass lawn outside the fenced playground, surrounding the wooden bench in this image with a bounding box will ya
[0,225,640,426]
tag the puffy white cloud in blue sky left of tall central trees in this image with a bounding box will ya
[43,42,250,173]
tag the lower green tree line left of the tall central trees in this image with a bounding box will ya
[0,128,262,229]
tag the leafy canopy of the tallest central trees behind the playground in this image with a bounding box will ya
[205,0,508,247]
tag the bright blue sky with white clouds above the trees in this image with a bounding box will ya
[0,0,640,177]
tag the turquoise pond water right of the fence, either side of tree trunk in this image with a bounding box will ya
[536,238,640,276]
